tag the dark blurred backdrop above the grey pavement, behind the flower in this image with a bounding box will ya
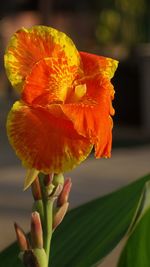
[0,0,150,157]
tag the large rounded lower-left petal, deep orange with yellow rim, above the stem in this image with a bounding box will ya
[7,101,92,173]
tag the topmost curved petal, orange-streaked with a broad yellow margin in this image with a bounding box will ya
[5,26,80,92]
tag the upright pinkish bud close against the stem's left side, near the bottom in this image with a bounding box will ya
[31,211,43,248]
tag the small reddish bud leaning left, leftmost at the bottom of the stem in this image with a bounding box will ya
[14,223,28,251]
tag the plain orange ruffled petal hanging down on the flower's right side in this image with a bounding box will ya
[62,76,114,158]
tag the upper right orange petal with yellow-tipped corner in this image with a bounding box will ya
[80,52,118,79]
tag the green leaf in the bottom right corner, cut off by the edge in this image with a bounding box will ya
[118,182,150,267]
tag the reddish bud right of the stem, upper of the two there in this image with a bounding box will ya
[57,178,72,206]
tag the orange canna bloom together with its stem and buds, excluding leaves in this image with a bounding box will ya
[2,26,150,267]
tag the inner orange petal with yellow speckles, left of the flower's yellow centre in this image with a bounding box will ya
[21,56,80,106]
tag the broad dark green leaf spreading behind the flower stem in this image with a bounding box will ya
[0,175,150,267]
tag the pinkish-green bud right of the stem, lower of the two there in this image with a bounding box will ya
[53,202,69,230]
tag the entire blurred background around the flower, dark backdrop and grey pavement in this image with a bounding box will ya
[0,0,150,267]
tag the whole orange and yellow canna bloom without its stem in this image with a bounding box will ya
[5,26,118,187]
